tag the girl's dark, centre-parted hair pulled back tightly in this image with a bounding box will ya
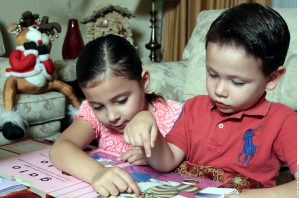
[76,34,160,102]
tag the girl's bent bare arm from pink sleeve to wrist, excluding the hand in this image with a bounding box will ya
[50,118,103,183]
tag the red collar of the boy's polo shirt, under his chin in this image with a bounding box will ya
[210,93,271,118]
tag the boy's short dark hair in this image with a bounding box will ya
[206,3,290,75]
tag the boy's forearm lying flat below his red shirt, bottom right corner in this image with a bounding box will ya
[225,172,297,198]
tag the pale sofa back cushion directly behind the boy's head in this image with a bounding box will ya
[183,8,297,110]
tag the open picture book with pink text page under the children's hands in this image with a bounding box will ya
[0,148,230,198]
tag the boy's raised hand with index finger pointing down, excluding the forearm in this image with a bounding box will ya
[124,111,158,157]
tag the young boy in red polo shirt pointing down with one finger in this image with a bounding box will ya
[124,3,297,198]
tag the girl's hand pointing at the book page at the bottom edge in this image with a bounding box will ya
[91,167,141,196]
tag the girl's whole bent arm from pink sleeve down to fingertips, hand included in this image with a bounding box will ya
[50,118,140,196]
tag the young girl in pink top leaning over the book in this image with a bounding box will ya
[50,35,182,196]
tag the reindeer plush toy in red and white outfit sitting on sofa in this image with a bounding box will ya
[0,11,80,140]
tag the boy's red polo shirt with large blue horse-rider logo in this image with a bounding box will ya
[166,96,297,187]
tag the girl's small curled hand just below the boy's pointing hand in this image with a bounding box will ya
[121,147,148,165]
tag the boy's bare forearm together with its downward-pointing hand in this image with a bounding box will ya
[124,111,185,172]
